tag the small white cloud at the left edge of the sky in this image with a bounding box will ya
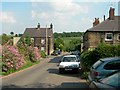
[0,12,16,23]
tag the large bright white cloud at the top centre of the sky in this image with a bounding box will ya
[50,0,88,15]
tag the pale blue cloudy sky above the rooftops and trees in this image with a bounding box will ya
[0,0,120,34]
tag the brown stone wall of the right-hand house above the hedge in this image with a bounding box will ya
[83,32,120,51]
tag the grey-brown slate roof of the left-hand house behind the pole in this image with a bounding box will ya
[22,28,53,37]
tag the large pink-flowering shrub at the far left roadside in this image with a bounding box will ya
[2,46,24,74]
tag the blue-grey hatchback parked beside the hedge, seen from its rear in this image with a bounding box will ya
[88,57,120,83]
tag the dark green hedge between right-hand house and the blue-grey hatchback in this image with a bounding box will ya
[81,44,120,71]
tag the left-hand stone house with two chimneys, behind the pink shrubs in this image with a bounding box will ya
[22,23,54,55]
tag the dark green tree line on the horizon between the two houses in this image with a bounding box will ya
[54,32,84,38]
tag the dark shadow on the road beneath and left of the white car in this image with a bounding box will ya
[47,68,81,78]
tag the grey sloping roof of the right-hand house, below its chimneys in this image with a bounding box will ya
[87,16,120,32]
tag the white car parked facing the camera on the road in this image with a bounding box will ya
[59,55,80,73]
